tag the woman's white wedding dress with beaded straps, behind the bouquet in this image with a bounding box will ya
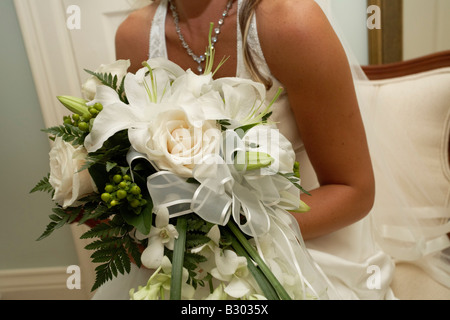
[94,0,395,300]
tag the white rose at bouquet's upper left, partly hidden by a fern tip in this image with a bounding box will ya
[81,60,131,100]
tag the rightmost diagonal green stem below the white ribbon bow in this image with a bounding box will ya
[227,221,291,300]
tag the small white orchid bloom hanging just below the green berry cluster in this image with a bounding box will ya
[136,207,178,269]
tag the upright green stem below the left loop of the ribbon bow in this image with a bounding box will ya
[170,216,187,300]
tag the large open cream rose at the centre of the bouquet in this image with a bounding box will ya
[128,108,222,177]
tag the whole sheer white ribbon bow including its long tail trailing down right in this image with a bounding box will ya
[127,131,326,298]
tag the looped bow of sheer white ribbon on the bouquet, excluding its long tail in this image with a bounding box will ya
[127,130,300,236]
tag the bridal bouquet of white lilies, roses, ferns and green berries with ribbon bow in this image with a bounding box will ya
[32,34,325,299]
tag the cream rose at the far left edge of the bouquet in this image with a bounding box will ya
[49,138,97,208]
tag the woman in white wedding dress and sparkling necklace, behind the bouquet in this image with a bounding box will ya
[94,0,394,299]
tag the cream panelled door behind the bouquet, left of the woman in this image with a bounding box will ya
[14,0,142,294]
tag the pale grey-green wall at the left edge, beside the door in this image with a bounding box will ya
[0,0,77,270]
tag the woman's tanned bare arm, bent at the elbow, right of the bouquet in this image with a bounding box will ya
[257,0,374,239]
